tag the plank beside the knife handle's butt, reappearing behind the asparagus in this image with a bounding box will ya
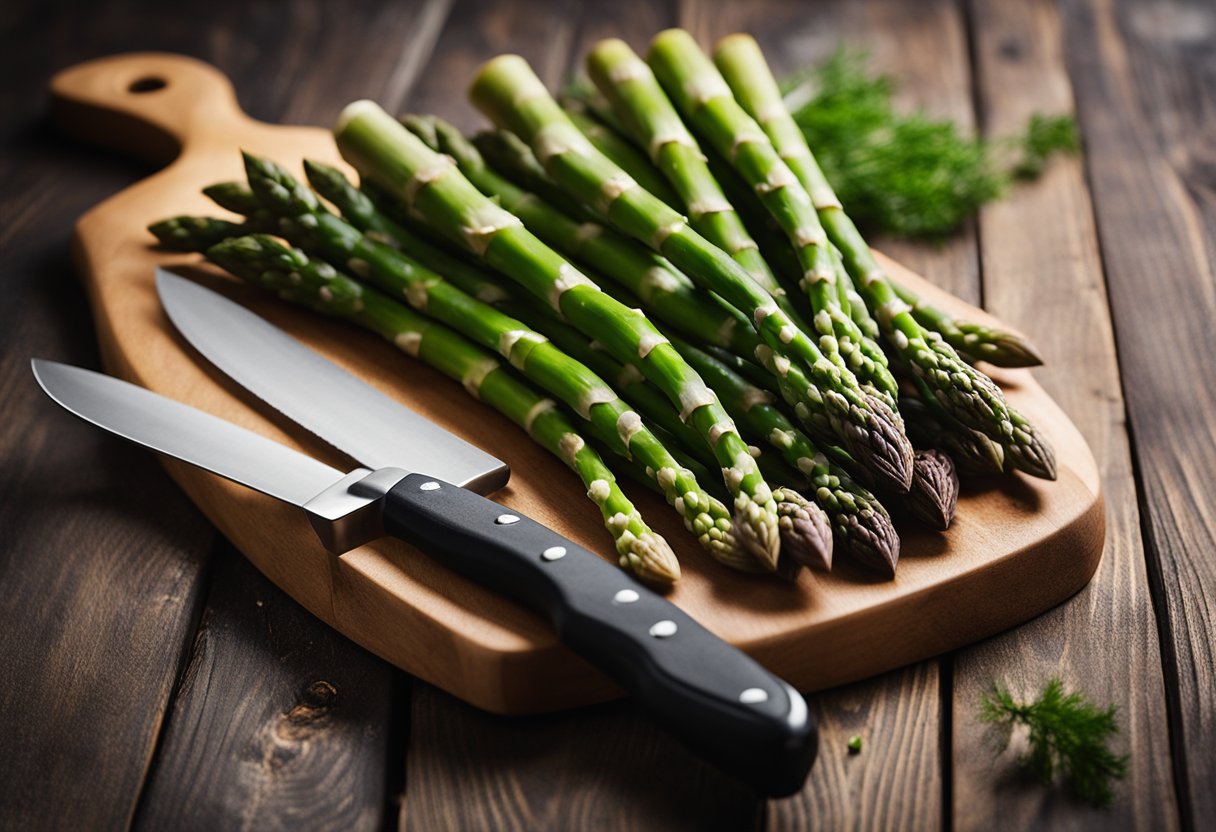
[685,0,980,830]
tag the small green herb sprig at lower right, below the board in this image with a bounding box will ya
[980,679,1128,806]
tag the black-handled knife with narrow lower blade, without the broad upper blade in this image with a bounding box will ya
[33,355,817,796]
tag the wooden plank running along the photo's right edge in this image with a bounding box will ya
[1063,0,1216,827]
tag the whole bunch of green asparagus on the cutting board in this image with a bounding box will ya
[151,29,1055,585]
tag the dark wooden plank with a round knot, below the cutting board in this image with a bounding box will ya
[135,541,398,831]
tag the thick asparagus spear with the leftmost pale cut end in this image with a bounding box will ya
[334,101,779,569]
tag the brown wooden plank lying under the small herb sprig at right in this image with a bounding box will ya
[953,0,1192,830]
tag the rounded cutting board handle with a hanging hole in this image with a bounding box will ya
[51,52,249,164]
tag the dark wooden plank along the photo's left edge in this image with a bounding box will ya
[0,4,210,830]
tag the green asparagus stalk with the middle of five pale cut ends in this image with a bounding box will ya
[575,38,789,299]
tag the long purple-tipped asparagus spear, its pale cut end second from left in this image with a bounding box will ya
[471,55,912,490]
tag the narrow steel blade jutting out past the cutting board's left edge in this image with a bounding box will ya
[30,359,345,506]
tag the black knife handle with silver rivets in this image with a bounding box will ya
[384,474,818,797]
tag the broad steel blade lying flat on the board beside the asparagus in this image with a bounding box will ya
[157,269,511,494]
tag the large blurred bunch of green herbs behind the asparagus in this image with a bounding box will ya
[784,50,1080,237]
